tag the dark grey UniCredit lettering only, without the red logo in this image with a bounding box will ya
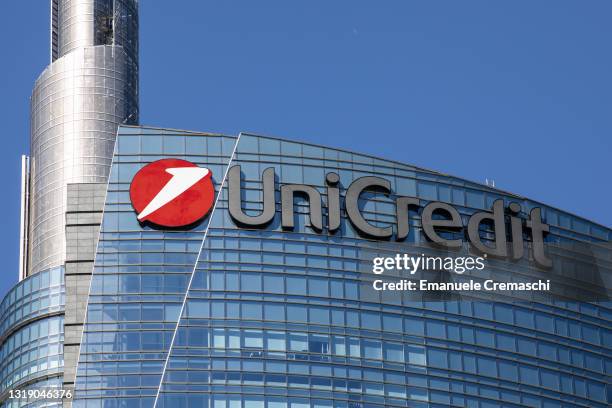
[228,166,552,268]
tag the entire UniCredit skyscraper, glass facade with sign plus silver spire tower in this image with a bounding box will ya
[0,0,612,408]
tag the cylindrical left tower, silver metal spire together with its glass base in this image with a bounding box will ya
[0,0,138,403]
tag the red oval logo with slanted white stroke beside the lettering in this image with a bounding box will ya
[130,159,215,227]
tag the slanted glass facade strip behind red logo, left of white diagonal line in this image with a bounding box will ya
[74,128,237,406]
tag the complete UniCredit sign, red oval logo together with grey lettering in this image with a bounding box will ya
[130,159,552,268]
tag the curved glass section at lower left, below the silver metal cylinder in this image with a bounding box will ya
[0,268,65,407]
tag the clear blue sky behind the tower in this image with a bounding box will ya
[0,0,612,294]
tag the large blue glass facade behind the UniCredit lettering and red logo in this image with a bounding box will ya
[69,127,612,408]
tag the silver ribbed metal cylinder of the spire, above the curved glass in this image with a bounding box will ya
[28,0,138,274]
